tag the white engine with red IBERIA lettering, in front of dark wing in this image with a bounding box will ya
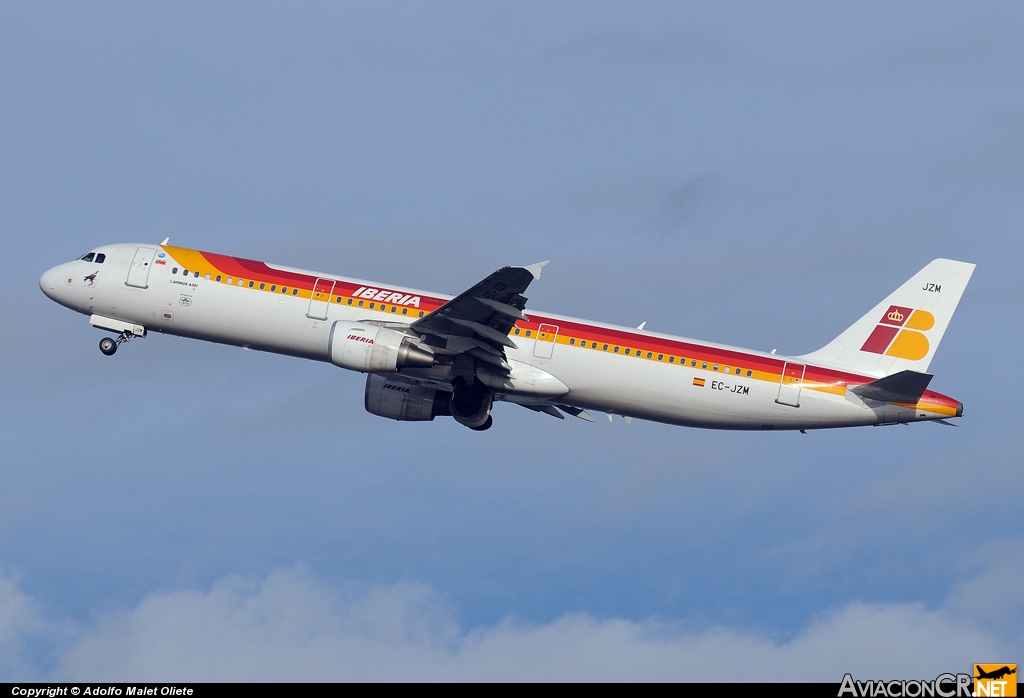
[329,320,434,373]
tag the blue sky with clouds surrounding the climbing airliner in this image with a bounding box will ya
[0,2,1024,681]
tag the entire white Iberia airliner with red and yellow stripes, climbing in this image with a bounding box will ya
[39,241,975,431]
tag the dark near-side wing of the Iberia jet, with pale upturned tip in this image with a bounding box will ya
[412,262,547,373]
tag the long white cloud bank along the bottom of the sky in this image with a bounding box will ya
[41,566,1008,682]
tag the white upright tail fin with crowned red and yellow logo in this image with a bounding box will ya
[799,259,975,376]
